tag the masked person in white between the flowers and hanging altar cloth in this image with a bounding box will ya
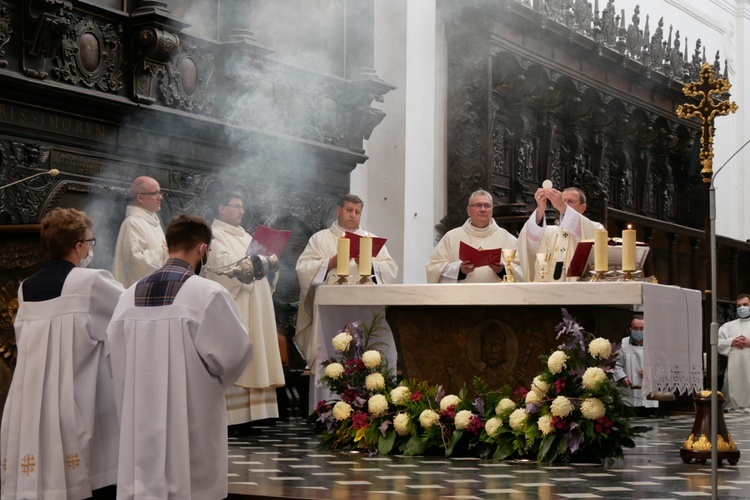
[612,314,659,416]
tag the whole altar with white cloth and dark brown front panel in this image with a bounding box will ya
[311,281,703,406]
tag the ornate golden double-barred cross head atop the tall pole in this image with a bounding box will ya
[677,63,737,183]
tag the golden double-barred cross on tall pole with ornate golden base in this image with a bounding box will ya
[677,63,740,492]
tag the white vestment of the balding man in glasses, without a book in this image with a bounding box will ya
[112,205,167,288]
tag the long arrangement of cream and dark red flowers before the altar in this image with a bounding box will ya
[311,309,648,462]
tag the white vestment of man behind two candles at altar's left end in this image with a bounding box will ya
[294,221,398,368]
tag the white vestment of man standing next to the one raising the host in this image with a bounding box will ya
[425,219,524,283]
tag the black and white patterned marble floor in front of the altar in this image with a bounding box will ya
[229,413,750,500]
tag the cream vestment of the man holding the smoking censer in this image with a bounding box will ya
[206,219,284,424]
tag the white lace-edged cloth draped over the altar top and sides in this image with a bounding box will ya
[310,281,703,409]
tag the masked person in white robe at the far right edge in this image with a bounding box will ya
[717,293,750,412]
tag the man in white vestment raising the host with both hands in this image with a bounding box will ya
[518,187,604,281]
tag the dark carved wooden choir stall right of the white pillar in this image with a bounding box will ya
[438,0,750,317]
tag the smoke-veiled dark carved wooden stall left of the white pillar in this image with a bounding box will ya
[0,0,392,418]
